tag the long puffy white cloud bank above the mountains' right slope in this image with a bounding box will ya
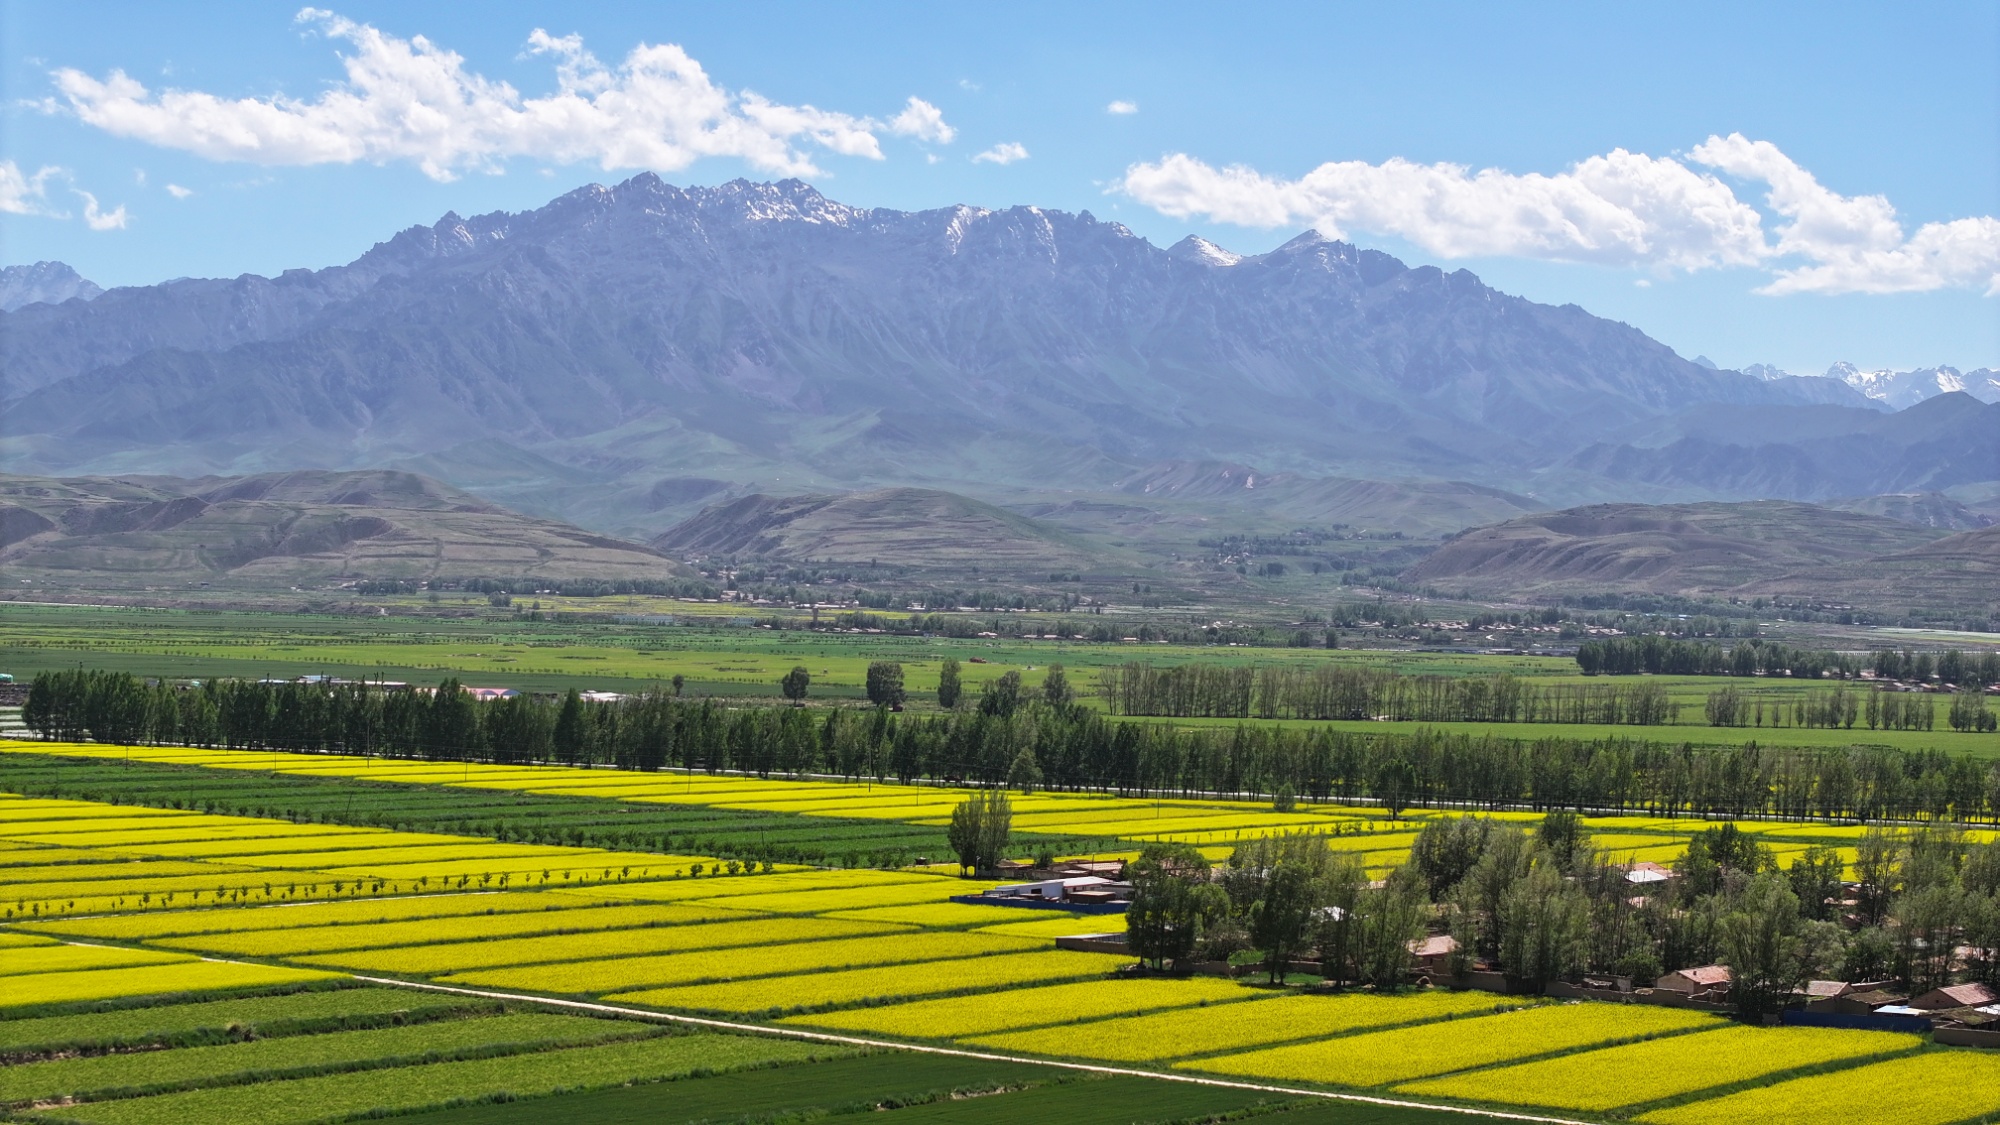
[1114,134,2000,292]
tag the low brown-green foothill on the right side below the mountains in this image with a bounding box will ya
[1404,500,1958,595]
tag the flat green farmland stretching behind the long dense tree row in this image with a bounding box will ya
[0,599,2000,755]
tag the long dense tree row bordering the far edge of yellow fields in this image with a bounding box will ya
[22,669,2000,823]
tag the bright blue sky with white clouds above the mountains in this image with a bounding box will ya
[0,0,2000,372]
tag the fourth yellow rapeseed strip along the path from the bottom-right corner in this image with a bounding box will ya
[972,991,1516,1063]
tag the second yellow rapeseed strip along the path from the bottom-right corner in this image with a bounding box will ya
[1396,1027,1922,1111]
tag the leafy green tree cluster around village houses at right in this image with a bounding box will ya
[1126,813,2000,1015]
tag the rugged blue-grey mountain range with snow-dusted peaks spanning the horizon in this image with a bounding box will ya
[0,174,2000,536]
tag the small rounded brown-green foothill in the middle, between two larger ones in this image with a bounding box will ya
[652,488,1098,571]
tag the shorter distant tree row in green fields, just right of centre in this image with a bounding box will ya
[1098,663,1680,727]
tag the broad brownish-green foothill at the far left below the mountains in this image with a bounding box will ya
[0,470,686,589]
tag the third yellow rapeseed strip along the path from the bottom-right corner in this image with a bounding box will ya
[1176,1003,1724,1087]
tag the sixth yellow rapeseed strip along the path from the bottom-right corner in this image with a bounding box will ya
[610,951,1130,1013]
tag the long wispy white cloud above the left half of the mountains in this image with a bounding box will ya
[50,8,952,180]
